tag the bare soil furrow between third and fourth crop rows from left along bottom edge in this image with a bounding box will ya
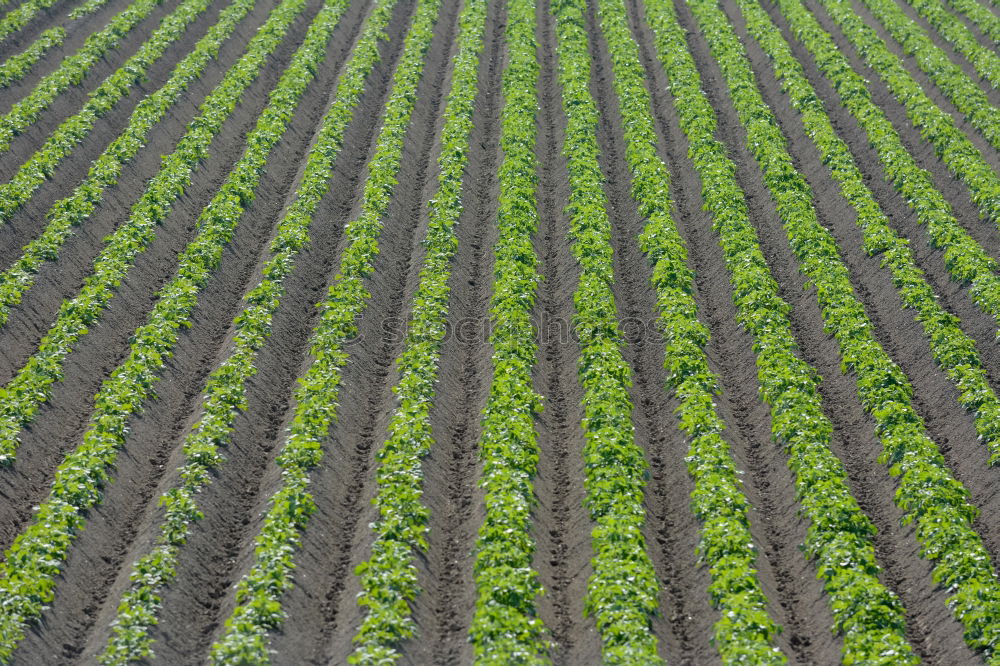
[260,2,461,664]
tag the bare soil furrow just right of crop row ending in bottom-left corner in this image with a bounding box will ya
[3,0,380,663]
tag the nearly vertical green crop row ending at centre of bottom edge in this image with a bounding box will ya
[469,0,549,666]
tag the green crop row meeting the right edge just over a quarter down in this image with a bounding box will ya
[808,0,1000,225]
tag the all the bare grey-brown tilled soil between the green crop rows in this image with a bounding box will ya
[0,0,1000,666]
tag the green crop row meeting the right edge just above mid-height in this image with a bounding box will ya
[772,0,1000,338]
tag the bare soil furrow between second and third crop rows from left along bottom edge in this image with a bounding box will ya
[119,2,428,664]
